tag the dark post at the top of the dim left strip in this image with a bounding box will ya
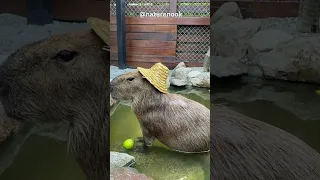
[27,0,53,26]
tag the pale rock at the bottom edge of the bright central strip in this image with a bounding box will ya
[110,167,153,180]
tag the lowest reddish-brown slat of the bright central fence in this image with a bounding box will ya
[110,53,176,63]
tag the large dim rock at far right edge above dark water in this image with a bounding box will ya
[257,35,320,84]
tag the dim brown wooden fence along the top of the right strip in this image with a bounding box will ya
[210,0,300,18]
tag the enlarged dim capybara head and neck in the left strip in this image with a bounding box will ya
[0,30,110,180]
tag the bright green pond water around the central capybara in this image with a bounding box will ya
[110,86,210,180]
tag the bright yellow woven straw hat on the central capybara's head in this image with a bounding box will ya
[137,63,169,93]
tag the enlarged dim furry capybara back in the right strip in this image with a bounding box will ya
[210,105,320,180]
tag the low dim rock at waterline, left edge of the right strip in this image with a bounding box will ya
[210,56,248,77]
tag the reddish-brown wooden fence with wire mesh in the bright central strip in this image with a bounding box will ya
[110,0,210,69]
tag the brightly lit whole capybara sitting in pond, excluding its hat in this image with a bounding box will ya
[110,70,210,153]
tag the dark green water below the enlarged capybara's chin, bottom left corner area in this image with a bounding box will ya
[0,135,85,180]
